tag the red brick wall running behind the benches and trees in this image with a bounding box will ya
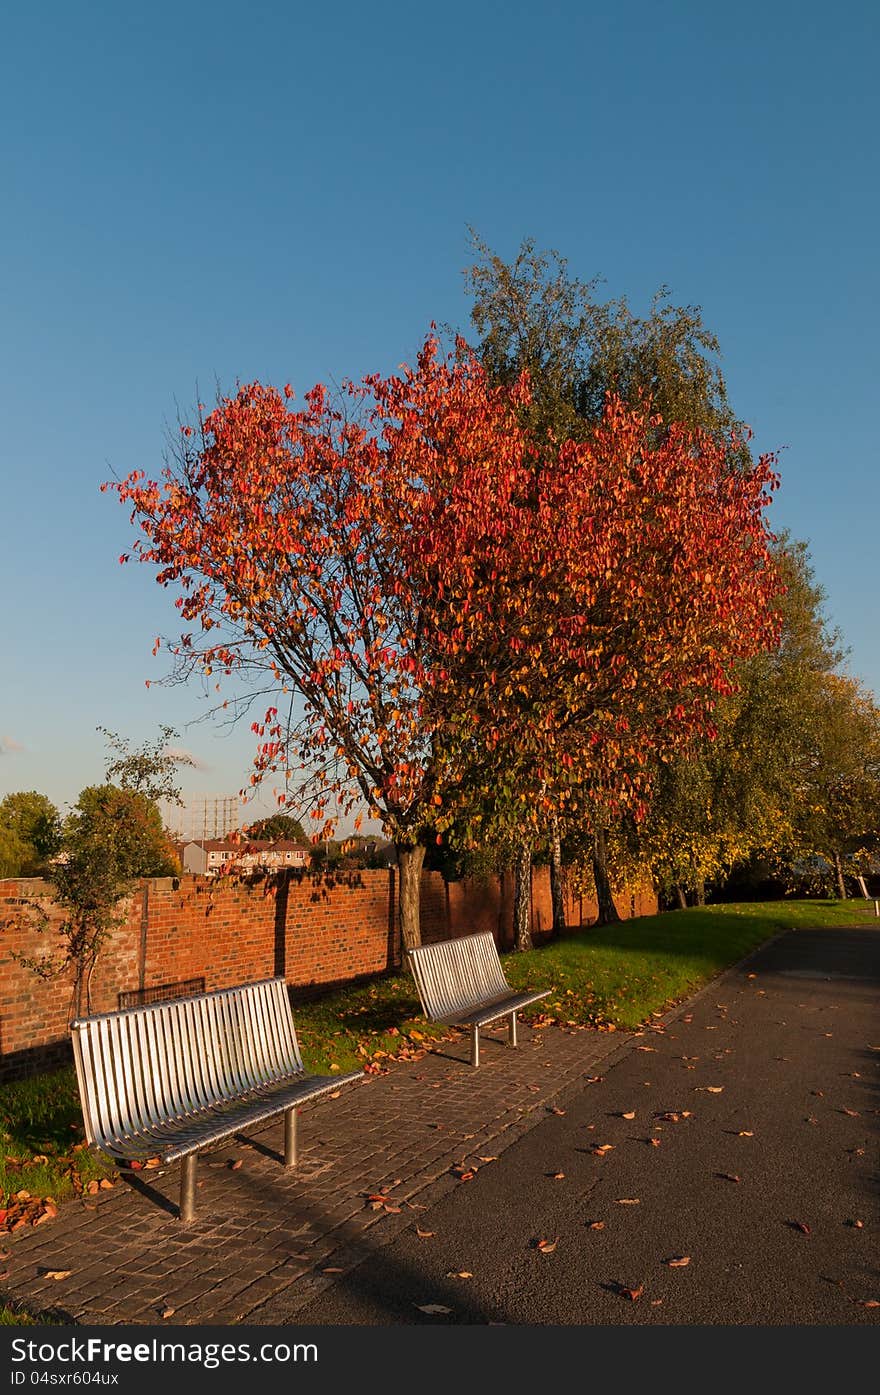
[0,868,657,1078]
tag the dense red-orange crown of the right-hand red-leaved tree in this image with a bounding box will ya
[420,399,780,937]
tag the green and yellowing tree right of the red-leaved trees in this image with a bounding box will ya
[637,534,874,904]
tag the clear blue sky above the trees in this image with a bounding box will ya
[0,0,880,805]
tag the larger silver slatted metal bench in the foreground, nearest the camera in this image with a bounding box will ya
[71,978,364,1222]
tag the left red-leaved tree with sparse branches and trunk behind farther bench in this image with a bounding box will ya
[106,339,541,944]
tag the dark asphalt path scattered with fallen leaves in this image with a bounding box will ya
[296,928,880,1325]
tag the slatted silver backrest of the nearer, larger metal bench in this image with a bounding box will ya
[71,978,303,1144]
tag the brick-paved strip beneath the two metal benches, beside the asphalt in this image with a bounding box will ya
[0,1027,630,1325]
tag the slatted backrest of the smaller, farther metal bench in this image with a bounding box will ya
[407,930,510,1021]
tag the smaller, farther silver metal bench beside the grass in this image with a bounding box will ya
[407,930,549,1066]
